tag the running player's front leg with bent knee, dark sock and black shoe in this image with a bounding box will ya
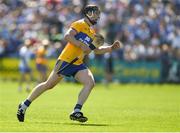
[70,69,95,122]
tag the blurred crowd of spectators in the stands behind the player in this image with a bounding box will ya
[0,0,180,83]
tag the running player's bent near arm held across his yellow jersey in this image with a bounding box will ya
[64,28,90,52]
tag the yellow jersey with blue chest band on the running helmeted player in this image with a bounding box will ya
[58,19,95,65]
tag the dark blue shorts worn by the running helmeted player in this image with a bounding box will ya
[56,60,87,77]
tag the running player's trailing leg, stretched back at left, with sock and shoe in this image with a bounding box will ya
[17,61,63,122]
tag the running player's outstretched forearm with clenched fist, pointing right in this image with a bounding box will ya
[94,40,123,54]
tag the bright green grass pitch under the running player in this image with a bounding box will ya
[0,81,180,132]
